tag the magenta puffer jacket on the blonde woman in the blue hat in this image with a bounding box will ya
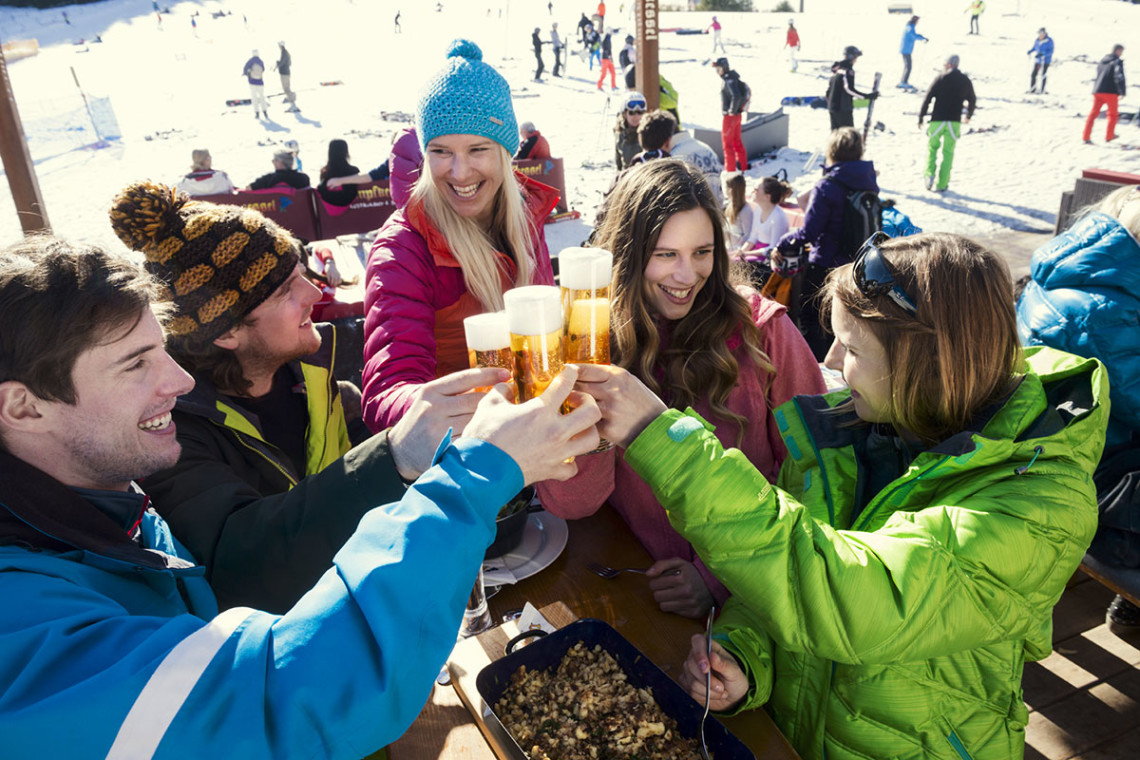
[363,130,559,432]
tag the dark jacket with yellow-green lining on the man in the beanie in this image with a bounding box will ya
[140,325,404,613]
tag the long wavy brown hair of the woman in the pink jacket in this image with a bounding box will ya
[592,158,774,443]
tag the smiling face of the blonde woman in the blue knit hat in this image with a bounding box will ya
[426,134,503,229]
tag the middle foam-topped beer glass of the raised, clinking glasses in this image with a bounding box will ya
[503,285,562,403]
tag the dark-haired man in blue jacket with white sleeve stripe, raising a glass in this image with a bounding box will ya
[0,238,599,760]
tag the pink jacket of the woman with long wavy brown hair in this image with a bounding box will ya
[538,291,825,606]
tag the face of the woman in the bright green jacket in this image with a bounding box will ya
[823,296,891,423]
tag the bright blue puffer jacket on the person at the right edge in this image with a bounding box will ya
[1017,212,1140,449]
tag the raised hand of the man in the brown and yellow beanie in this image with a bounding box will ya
[388,367,511,481]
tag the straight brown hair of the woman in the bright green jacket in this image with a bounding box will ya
[821,232,1024,446]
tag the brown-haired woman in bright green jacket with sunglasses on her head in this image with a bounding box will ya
[579,234,1108,760]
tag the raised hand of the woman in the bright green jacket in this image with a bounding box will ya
[575,365,668,448]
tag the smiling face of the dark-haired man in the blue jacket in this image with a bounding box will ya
[41,309,194,491]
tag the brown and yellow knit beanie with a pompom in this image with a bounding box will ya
[111,182,301,342]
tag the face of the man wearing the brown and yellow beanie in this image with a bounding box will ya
[215,264,320,379]
